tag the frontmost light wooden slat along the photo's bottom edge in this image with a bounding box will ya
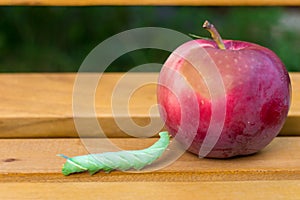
[0,180,300,200]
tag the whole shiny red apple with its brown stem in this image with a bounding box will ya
[157,21,291,158]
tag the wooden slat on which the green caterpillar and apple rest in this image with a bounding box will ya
[0,137,300,183]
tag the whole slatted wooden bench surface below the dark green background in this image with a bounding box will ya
[0,73,300,200]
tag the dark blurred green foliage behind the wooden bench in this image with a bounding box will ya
[0,6,300,72]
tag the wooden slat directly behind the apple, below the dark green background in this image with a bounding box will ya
[0,73,300,138]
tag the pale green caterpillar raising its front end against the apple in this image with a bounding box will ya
[58,132,170,176]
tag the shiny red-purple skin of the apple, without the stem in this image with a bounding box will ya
[157,39,291,158]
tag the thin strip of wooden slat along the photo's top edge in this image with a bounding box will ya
[0,0,300,6]
